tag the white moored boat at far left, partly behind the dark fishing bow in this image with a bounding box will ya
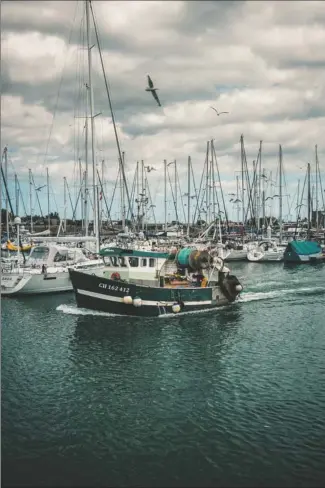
[1,244,103,296]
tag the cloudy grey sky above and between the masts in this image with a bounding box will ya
[1,1,325,225]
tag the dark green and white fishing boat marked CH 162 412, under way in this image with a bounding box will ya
[69,248,243,317]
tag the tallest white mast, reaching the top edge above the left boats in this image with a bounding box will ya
[86,0,99,253]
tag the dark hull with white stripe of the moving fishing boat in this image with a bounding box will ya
[69,268,242,317]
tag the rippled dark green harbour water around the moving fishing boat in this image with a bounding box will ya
[1,263,325,487]
